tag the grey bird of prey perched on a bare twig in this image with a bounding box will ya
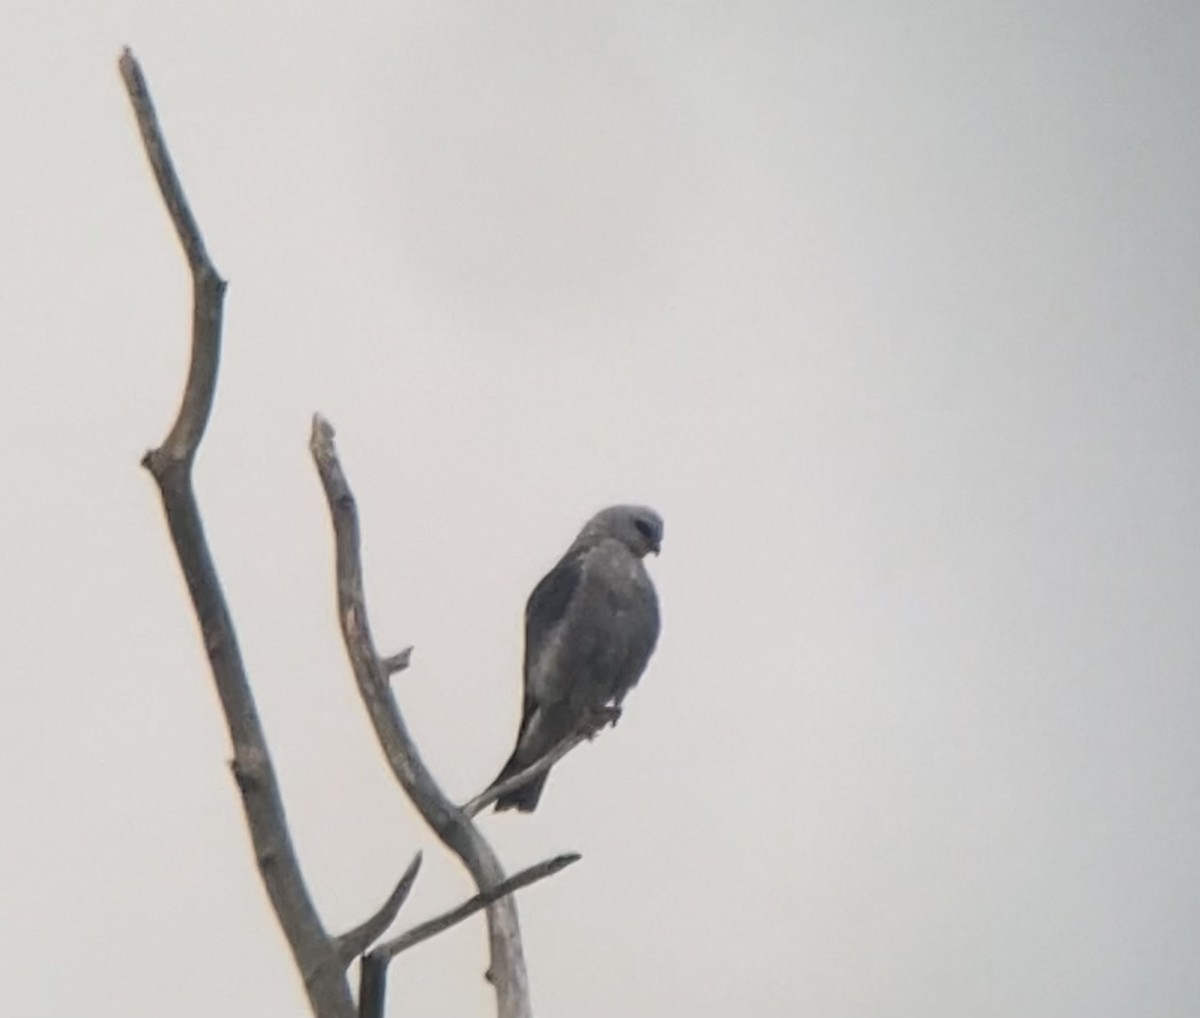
[491,505,662,813]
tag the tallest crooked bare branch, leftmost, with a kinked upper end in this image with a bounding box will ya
[119,49,354,1018]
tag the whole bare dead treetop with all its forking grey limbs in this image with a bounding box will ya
[129,49,582,1018]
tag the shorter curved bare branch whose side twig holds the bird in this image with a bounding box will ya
[310,415,530,1018]
